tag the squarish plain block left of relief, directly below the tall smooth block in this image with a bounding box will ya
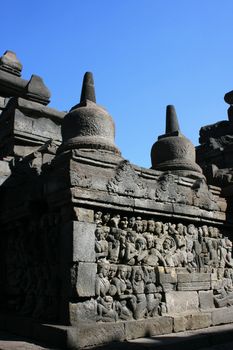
[76,263,97,297]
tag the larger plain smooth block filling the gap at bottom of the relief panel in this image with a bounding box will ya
[165,291,199,313]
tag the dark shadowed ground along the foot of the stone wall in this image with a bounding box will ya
[0,325,233,350]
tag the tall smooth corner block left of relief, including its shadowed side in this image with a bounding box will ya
[61,221,96,262]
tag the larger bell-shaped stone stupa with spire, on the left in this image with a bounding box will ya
[61,72,120,155]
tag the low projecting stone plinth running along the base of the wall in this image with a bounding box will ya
[0,307,233,349]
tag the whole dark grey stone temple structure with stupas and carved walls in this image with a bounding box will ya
[0,51,233,349]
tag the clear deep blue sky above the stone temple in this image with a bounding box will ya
[0,0,233,167]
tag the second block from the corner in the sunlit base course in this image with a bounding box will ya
[125,316,173,340]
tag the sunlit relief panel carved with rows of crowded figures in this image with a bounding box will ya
[90,211,233,322]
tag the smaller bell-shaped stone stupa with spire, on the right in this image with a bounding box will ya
[151,105,204,178]
